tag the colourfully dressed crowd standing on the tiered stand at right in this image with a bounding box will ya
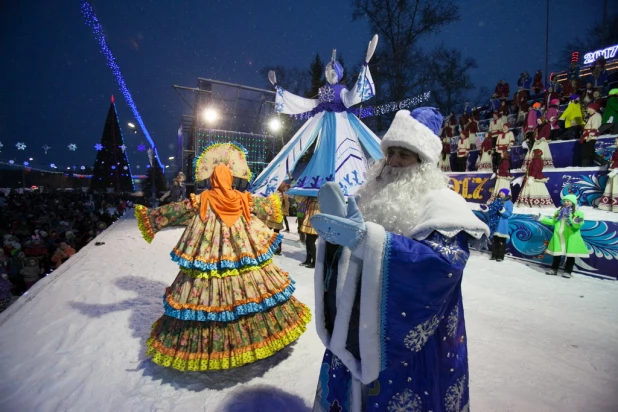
[440,57,618,172]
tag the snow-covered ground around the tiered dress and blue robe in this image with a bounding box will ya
[0,216,618,412]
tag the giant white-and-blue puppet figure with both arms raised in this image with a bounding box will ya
[249,35,382,197]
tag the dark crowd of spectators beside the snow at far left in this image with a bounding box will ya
[0,190,132,312]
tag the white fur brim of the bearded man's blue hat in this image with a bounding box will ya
[380,110,442,165]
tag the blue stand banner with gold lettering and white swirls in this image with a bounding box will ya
[446,167,608,206]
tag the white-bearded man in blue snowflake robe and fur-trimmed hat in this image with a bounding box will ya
[311,107,489,412]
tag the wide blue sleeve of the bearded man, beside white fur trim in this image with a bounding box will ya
[381,232,470,359]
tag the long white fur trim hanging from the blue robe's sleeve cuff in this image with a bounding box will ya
[328,222,386,384]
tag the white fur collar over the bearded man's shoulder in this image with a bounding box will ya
[406,189,489,240]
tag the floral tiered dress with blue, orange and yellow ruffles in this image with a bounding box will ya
[135,194,311,371]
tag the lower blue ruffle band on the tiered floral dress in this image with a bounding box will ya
[163,278,296,322]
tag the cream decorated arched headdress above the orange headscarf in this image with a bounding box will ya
[193,143,252,181]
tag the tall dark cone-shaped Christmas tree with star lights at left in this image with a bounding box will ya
[90,96,134,192]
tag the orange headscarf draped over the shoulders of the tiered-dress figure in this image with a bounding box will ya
[200,164,251,227]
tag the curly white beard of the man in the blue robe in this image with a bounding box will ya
[357,159,448,236]
